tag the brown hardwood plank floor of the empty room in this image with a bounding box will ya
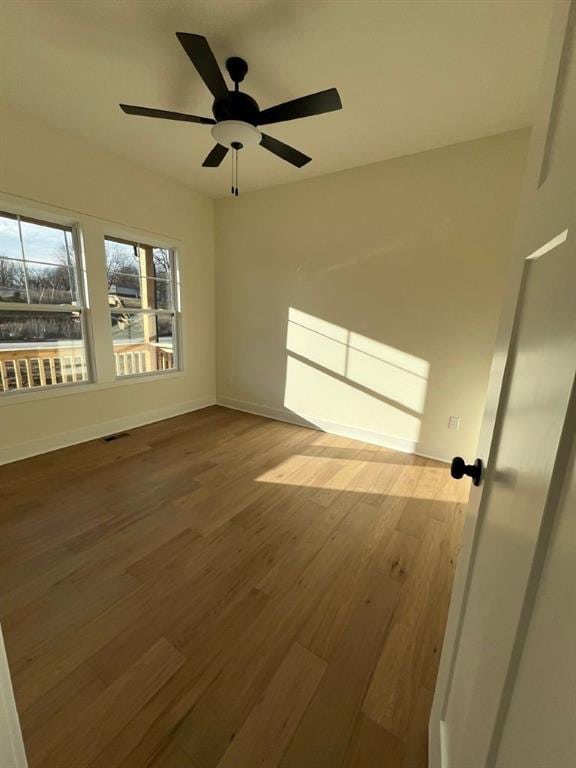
[0,406,468,768]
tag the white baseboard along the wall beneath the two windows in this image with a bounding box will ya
[0,395,216,465]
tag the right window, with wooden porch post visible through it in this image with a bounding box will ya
[105,238,178,376]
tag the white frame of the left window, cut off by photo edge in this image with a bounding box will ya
[0,212,96,401]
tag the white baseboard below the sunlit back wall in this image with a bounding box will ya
[216,397,449,462]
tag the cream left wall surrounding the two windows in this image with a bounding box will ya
[0,108,214,460]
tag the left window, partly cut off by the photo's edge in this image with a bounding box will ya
[0,212,89,393]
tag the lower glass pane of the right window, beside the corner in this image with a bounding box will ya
[111,312,175,376]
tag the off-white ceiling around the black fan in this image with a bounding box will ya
[0,0,551,197]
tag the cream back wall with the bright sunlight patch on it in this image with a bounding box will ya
[216,131,529,460]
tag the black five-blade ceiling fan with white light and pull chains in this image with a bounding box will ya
[120,32,342,195]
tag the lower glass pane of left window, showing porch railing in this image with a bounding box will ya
[0,311,88,391]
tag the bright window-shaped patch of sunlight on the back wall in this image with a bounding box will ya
[284,307,430,450]
